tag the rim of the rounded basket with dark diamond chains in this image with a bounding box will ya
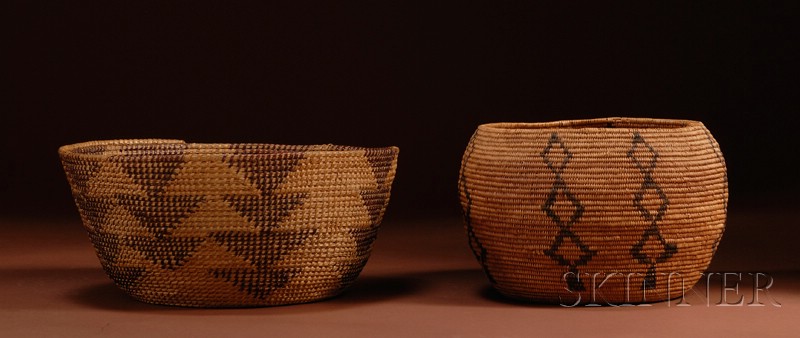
[478,117,705,132]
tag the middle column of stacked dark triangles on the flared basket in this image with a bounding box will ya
[210,145,316,300]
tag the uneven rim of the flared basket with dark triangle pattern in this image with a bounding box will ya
[58,138,400,159]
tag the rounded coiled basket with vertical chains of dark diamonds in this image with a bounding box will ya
[459,118,728,305]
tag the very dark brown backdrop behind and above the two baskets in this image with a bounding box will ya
[0,1,800,220]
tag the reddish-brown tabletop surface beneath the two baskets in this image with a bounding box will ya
[0,213,800,337]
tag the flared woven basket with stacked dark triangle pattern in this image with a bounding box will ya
[59,140,398,307]
